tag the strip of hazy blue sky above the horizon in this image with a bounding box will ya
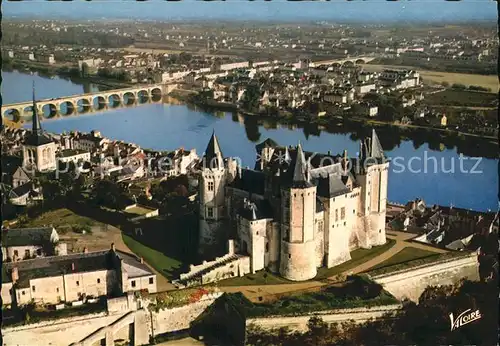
[2,0,497,23]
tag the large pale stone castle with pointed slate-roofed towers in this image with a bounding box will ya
[198,130,389,281]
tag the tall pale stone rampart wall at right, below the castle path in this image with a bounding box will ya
[372,254,479,302]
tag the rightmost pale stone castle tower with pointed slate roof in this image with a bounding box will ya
[358,130,389,247]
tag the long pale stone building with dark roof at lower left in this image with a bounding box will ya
[1,245,156,305]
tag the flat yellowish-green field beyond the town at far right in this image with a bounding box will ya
[362,64,499,92]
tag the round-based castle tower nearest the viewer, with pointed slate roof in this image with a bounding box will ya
[280,144,317,281]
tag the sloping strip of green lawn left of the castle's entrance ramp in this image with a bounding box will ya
[122,233,182,280]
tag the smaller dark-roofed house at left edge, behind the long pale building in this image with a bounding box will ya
[2,227,67,262]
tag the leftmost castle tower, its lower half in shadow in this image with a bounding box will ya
[198,132,227,257]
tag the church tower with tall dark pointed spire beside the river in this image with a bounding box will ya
[23,82,57,172]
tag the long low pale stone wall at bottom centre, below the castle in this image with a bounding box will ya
[246,304,401,332]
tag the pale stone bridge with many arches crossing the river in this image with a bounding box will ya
[1,83,178,122]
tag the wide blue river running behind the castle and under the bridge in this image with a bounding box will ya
[2,71,498,211]
